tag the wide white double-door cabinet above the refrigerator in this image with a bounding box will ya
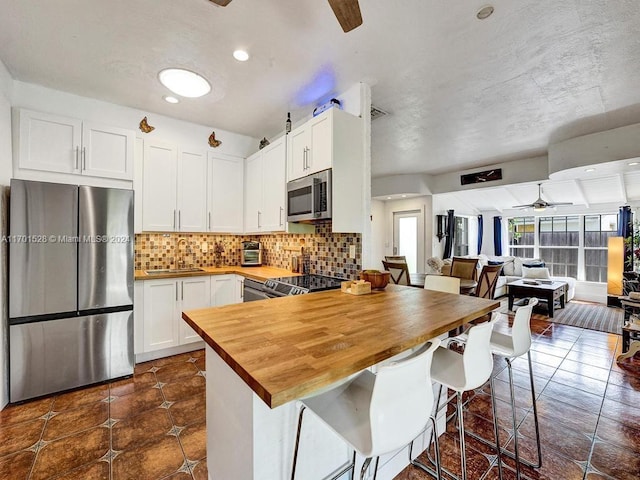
[16,109,135,180]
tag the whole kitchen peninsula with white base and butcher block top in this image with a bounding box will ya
[182,285,499,480]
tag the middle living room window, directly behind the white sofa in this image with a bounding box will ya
[538,215,580,278]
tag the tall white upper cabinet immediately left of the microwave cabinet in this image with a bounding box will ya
[244,137,287,232]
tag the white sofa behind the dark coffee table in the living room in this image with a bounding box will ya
[442,254,576,302]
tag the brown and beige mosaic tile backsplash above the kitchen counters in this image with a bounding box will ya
[135,221,362,279]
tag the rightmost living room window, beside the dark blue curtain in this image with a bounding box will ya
[584,215,618,282]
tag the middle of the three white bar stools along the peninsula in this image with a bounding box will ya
[413,319,502,480]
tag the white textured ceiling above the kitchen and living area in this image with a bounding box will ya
[0,0,640,193]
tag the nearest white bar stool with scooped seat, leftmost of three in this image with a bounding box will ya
[291,339,441,480]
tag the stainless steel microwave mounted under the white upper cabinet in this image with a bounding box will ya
[287,169,331,223]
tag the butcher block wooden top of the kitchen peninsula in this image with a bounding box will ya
[182,285,500,408]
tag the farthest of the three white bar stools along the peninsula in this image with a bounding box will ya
[453,297,542,480]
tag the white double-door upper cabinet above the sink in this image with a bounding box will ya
[142,141,208,232]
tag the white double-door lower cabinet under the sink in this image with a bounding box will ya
[142,276,211,352]
